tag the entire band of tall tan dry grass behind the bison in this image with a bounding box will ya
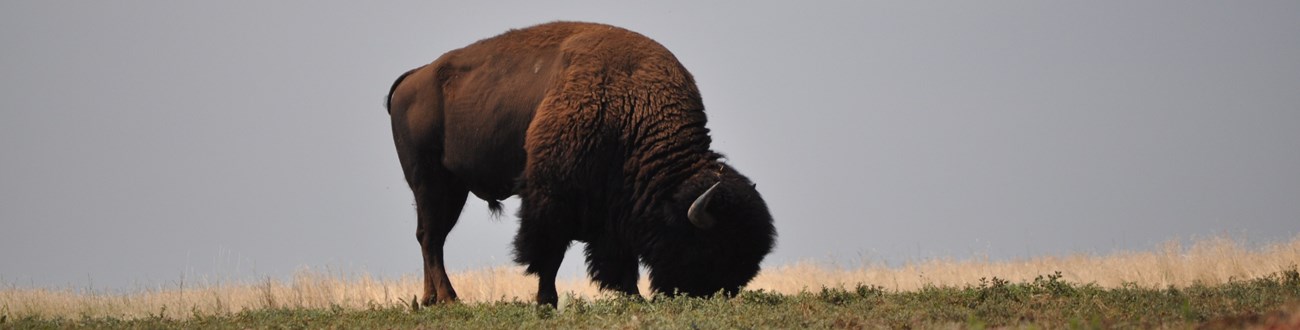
[0,236,1300,318]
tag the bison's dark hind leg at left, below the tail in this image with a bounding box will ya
[415,175,469,305]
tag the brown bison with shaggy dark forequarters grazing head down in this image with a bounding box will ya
[387,22,776,305]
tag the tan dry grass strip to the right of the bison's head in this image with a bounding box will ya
[749,236,1300,292]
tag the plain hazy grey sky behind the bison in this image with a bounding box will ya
[0,0,1300,290]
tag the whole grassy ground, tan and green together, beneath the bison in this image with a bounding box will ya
[0,238,1300,329]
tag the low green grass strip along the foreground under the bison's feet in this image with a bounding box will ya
[10,268,1300,329]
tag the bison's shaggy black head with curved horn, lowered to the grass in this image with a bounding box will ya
[641,166,776,296]
